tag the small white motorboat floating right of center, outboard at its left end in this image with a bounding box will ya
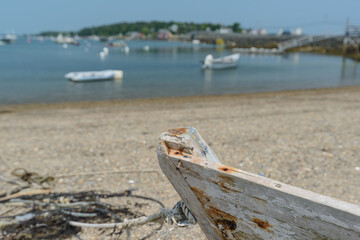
[202,53,240,69]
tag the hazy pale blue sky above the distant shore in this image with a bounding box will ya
[0,0,360,34]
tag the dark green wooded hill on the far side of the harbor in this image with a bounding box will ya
[40,21,242,36]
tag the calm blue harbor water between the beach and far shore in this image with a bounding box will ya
[0,39,360,104]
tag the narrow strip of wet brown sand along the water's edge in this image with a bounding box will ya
[0,86,360,111]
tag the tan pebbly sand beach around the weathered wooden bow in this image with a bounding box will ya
[0,87,360,239]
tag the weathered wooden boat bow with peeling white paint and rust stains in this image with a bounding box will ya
[158,128,360,240]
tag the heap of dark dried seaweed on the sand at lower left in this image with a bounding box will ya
[0,189,164,240]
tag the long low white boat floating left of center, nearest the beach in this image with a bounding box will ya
[65,70,123,82]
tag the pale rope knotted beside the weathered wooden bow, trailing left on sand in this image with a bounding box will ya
[69,200,196,230]
